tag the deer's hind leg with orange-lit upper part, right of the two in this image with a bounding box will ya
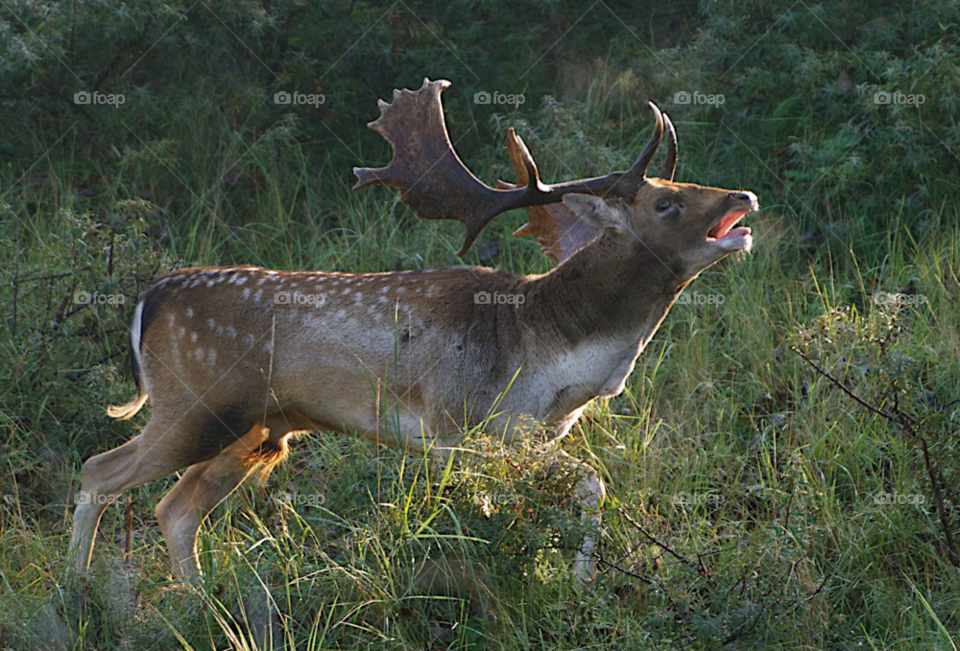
[156,425,269,578]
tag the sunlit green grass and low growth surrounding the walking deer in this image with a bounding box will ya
[0,88,960,649]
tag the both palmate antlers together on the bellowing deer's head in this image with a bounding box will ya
[353,78,677,261]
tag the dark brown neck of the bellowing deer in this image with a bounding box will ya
[527,234,686,354]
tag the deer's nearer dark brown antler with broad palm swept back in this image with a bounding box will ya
[353,78,664,256]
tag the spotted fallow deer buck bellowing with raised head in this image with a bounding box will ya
[71,79,757,578]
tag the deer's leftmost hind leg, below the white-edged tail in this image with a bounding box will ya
[69,421,193,573]
